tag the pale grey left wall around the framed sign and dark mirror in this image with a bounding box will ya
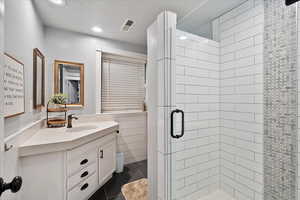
[4,0,47,137]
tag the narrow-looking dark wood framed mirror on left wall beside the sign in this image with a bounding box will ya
[33,48,45,109]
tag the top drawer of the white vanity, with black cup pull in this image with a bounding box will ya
[67,149,97,177]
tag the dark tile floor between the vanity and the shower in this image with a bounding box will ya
[89,160,147,200]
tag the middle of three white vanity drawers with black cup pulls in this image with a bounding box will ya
[68,163,97,190]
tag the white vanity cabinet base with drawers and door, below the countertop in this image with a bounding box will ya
[20,131,116,200]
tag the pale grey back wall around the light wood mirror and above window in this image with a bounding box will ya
[45,27,146,114]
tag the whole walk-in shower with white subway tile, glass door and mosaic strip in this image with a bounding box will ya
[147,0,300,200]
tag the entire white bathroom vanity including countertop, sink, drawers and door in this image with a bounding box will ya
[19,121,119,200]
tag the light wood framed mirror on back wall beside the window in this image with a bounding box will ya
[54,60,84,106]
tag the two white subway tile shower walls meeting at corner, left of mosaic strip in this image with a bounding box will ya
[172,0,300,200]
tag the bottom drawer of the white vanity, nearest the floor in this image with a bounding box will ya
[68,174,98,200]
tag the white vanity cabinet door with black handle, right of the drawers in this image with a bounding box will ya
[99,141,116,185]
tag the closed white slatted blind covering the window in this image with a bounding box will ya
[101,53,145,112]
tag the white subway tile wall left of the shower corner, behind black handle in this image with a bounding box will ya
[172,30,219,200]
